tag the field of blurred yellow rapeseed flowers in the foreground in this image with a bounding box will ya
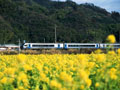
[0,49,120,90]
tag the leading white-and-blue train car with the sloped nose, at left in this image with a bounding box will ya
[23,43,63,49]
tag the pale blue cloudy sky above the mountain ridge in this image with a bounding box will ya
[53,0,120,12]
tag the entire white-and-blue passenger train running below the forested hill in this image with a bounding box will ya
[22,43,120,49]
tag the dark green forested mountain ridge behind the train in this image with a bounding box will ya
[0,0,120,44]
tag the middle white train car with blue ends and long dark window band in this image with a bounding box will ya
[64,43,99,49]
